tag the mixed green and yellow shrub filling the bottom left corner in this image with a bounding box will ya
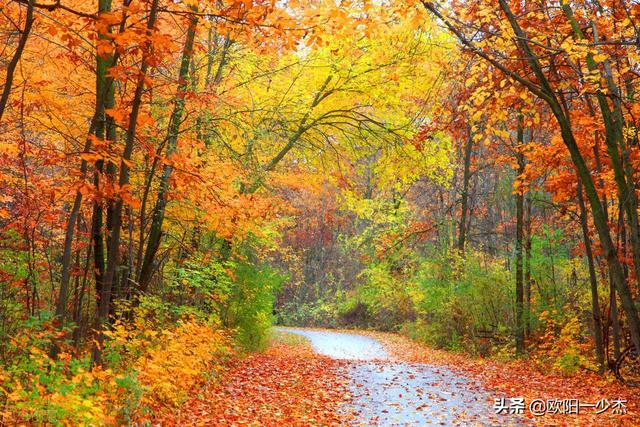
[0,313,141,426]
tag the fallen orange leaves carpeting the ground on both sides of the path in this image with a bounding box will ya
[168,332,640,426]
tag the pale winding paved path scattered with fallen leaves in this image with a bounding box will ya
[277,328,526,426]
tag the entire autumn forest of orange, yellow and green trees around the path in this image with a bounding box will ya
[0,0,640,425]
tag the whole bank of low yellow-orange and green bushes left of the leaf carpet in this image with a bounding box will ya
[0,310,233,426]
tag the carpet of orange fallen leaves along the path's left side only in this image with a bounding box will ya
[160,334,348,426]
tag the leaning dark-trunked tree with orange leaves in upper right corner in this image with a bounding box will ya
[423,1,640,354]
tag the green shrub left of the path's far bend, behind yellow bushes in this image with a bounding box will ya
[161,235,286,351]
